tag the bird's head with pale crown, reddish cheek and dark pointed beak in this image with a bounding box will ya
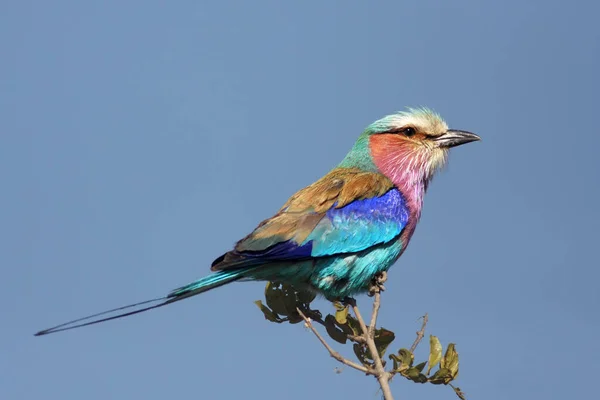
[342,108,480,203]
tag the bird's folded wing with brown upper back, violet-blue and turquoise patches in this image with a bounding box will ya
[212,168,409,270]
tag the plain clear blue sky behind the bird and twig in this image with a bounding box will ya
[0,0,600,400]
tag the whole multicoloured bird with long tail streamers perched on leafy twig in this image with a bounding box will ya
[35,107,481,336]
